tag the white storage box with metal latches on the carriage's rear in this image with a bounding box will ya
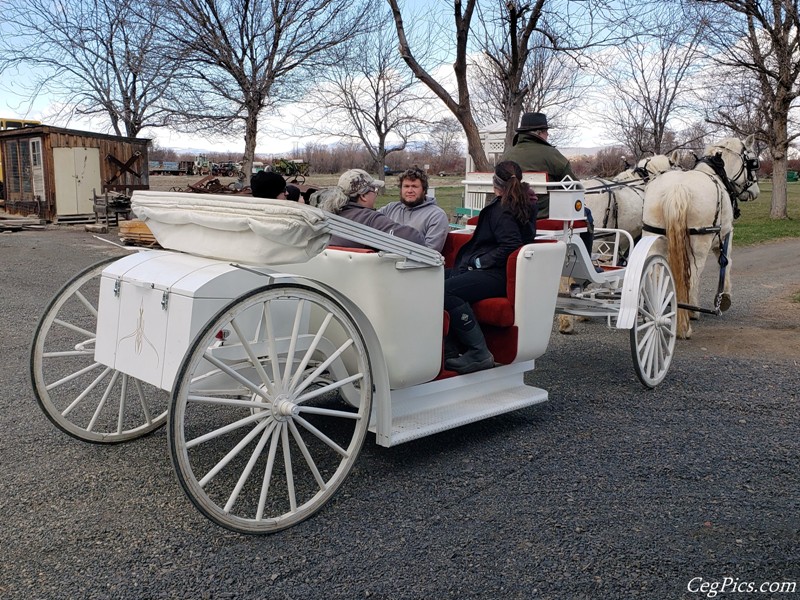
[95,251,274,390]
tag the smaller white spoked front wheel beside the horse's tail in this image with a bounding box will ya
[631,255,678,388]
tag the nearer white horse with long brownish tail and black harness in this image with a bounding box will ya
[643,135,759,339]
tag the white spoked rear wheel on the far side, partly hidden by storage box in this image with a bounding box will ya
[30,258,169,444]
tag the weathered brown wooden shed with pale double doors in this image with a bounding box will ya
[0,125,150,221]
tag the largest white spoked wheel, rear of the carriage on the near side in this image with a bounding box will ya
[169,284,373,533]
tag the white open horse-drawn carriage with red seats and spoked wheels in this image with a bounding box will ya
[31,180,675,533]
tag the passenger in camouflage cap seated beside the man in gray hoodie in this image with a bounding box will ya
[309,169,425,248]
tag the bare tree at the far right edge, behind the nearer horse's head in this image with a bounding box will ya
[698,0,800,219]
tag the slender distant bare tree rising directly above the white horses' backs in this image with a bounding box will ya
[595,0,708,156]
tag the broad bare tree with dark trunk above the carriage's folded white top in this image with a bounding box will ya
[164,0,376,177]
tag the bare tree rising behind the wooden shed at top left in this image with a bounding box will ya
[0,0,176,137]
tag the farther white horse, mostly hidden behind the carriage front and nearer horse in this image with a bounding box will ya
[558,153,675,334]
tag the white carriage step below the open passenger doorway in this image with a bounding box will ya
[370,361,547,446]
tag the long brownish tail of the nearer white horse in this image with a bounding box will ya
[662,184,692,338]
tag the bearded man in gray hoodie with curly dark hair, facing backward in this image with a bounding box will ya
[378,168,450,252]
